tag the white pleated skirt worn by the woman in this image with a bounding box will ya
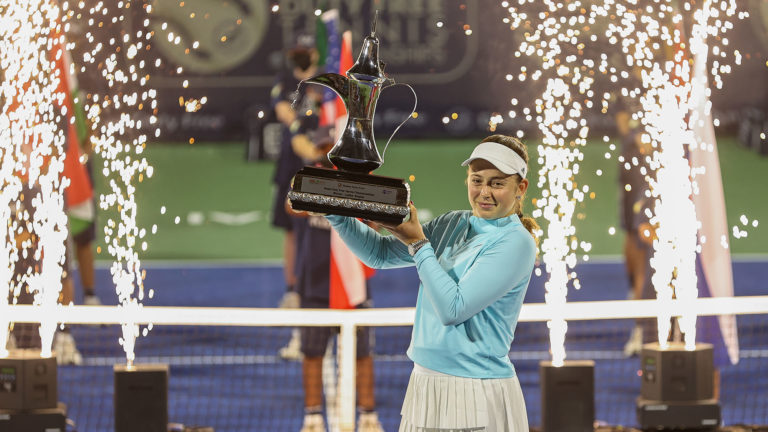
[400,364,528,432]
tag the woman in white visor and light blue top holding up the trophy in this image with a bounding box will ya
[327,135,538,432]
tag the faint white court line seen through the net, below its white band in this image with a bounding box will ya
[82,349,768,366]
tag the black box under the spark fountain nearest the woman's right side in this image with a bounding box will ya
[539,360,595,432]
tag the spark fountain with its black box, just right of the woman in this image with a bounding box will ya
[504,1,594,432]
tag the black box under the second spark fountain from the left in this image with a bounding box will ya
[114,364,168,432]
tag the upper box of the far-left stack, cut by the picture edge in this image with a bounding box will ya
[0,349,58,410]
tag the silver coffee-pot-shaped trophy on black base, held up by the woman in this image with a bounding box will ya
[288,12,413,223]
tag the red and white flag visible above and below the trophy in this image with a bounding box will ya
[317,9,373,309]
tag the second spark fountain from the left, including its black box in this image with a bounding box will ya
[66,2,169,432]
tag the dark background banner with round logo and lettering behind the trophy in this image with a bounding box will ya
[83,0,768,141]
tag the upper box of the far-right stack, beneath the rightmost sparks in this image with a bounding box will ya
[640,342,714,402]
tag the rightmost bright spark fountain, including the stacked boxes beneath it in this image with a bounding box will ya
[637,1,737,429]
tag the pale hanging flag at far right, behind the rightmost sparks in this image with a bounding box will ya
[688,42,739,366]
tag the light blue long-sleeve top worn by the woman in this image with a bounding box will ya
[327,211,536,378]
